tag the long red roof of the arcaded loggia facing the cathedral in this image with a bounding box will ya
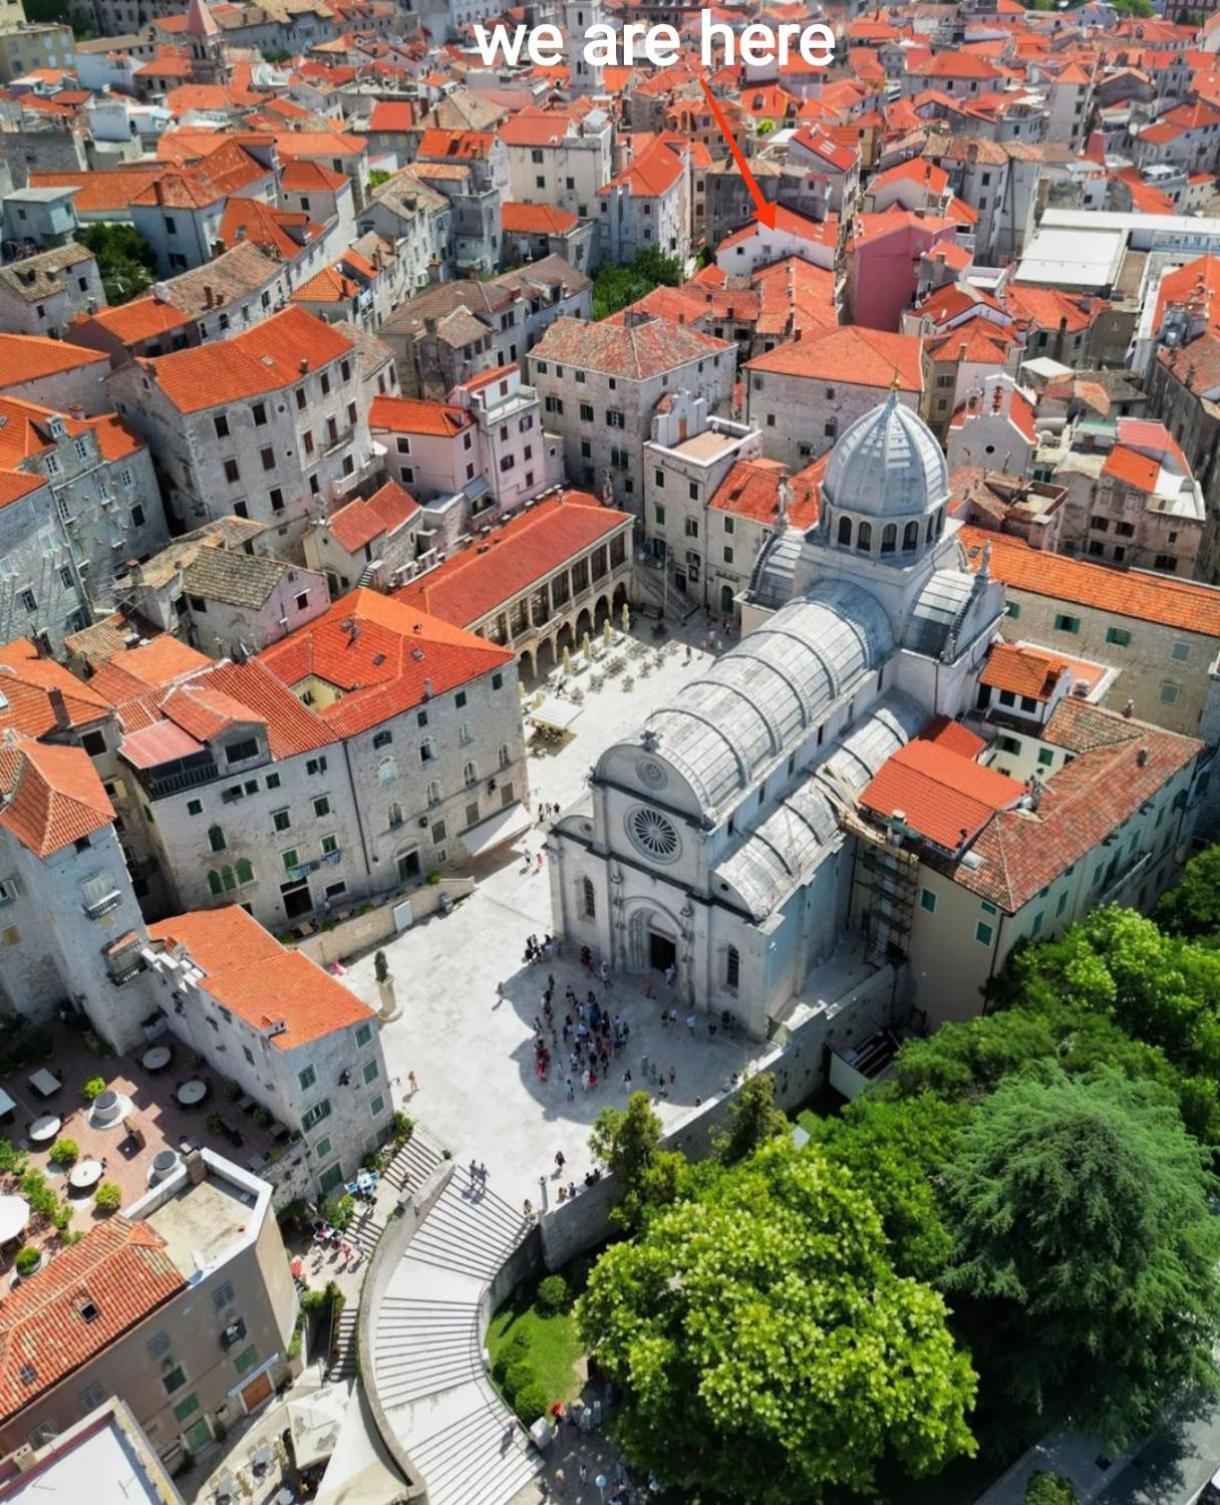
[394,491,630,626]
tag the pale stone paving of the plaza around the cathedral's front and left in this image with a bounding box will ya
[344,622,763,1206]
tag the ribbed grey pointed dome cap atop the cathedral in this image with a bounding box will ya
[821,391,949,518]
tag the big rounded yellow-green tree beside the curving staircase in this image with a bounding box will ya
[578,1139,975,1505]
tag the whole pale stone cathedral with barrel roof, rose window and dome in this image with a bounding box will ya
[549,394,1005,1038]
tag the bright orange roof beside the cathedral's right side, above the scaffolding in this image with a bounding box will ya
[860,737,1026,852]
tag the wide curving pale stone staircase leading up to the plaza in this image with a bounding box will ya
[372,1167,543,1505]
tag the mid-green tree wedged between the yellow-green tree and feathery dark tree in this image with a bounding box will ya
[812,1090,970,1281]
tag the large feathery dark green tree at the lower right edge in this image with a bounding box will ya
[943,1064,1220,1443]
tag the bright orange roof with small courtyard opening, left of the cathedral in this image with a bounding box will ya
[254,586,511,737]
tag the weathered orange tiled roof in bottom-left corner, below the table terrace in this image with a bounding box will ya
[0,1216,187,1421]
